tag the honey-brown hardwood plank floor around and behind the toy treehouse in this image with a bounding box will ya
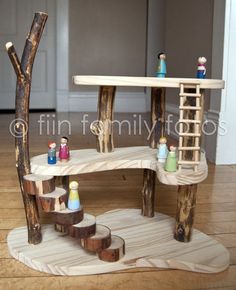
[0,113,236,290]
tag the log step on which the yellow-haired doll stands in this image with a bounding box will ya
[52,206,84,226]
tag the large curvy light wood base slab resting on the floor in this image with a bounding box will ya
[7,209,229,275]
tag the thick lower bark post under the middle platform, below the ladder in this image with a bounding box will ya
[174,184,197,242]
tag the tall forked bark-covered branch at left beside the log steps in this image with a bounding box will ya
[6,12,48,244]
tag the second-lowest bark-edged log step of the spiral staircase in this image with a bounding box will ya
[80,225,111,252]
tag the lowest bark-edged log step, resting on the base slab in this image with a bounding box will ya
[98,235,125,262]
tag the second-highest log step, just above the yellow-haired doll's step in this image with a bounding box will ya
[37,187,68,212]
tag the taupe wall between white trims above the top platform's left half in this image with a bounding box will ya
[69,0,147,91]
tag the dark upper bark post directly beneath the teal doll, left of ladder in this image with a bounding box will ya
[150,88,166,149]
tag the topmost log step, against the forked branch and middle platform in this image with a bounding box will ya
[23,174,55,195]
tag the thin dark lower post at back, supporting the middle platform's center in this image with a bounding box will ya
[142,169,156,217]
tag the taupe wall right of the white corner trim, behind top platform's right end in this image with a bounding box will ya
[165,0,214,109]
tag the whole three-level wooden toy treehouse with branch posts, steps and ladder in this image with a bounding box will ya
[6,13,229,275]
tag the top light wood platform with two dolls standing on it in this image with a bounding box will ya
[73,75,225,89]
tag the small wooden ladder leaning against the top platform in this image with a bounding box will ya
[178,83,202,171]
